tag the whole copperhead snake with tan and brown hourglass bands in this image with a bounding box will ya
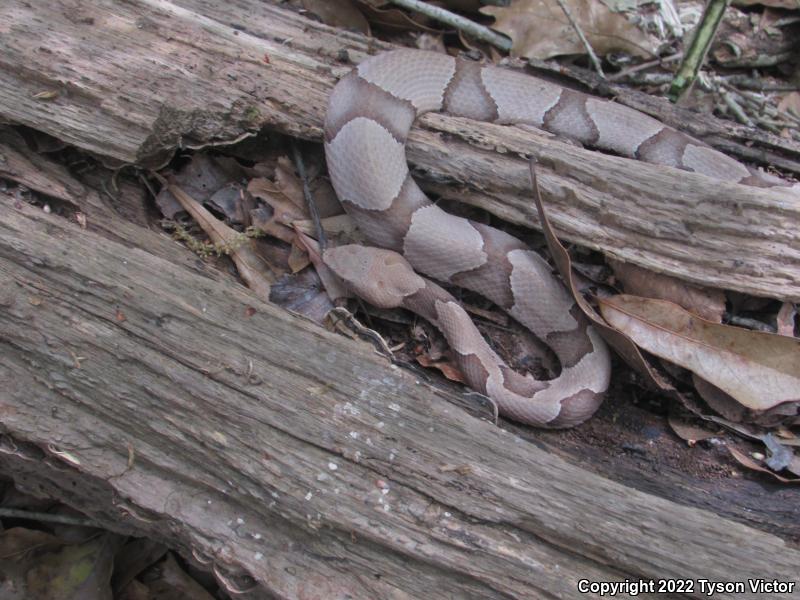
[323,50,783,428]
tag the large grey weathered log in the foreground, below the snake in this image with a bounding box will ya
[0,195,800,598]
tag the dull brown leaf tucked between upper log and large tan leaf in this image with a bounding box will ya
[608,258,725,323]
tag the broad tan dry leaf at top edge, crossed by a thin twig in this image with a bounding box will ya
[481,0,658,59]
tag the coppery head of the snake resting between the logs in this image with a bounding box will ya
[322,244,425,308]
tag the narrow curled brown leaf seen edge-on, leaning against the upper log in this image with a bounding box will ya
[530,162,676,394]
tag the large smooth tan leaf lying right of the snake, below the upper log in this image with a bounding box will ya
[599,294,800,411]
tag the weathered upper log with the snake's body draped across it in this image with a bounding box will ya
[0,0,800,300]
